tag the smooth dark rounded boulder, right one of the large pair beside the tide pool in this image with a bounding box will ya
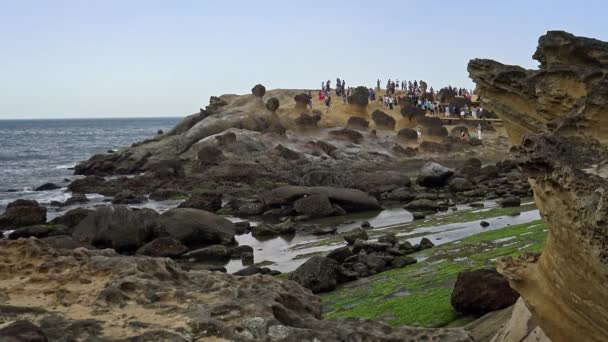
[158,208,236,248]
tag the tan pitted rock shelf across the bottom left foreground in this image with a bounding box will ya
[0,238,472,342]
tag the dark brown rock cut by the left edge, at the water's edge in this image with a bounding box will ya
[0,199,46,229]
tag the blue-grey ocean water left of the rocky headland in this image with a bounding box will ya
[0,117,181,213]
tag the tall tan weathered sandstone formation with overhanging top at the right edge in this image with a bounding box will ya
[468,32,608,341]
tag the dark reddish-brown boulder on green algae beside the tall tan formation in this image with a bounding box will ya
[451,269,519,316]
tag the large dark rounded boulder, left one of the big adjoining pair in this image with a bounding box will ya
[72,205,158,253]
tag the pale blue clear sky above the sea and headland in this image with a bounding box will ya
[0,0,608,119]
